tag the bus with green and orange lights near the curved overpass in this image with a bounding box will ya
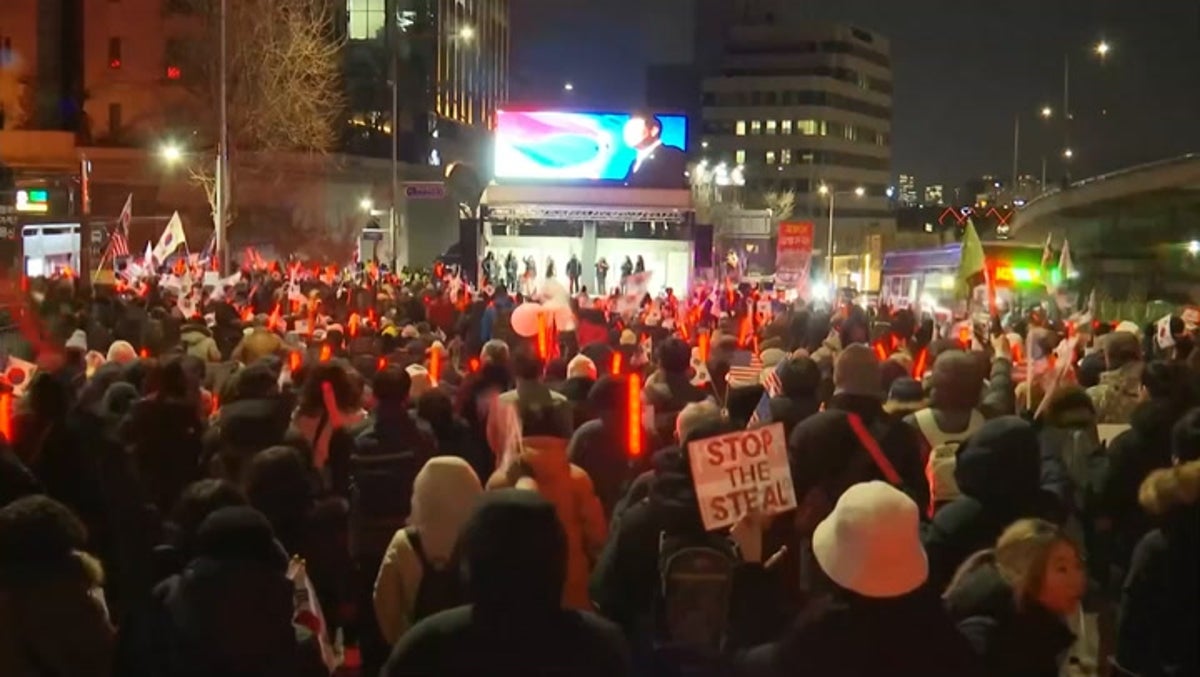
[880,242,1058,317]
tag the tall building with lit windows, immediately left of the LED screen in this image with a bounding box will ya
[343,0,510,163]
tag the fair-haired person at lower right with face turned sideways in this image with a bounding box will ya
[944,520,1087,677]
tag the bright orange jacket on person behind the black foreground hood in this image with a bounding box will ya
[487,427,608,610]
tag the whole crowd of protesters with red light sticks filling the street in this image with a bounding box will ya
[0,266,1200,677]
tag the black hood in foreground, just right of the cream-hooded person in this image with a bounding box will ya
[461,489,566,618]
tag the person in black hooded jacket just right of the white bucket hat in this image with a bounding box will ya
[922,417,1066,589]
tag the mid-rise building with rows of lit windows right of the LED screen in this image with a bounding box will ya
[702,18,895,288]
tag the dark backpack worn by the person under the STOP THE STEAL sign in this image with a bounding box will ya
[654,532,739,671]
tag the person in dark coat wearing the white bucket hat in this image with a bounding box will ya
[731,481,979,677]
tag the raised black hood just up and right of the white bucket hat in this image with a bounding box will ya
[954,417,1042,502]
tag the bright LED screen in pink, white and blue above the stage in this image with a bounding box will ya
[496,110,688,187]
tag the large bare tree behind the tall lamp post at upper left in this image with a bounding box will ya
[181,0,344,225]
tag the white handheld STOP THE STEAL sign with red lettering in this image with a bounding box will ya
[688,424,796,531]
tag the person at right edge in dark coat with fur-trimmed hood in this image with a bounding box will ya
[1114,441,1200,677]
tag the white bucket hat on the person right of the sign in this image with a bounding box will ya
[812,481,929,598]
